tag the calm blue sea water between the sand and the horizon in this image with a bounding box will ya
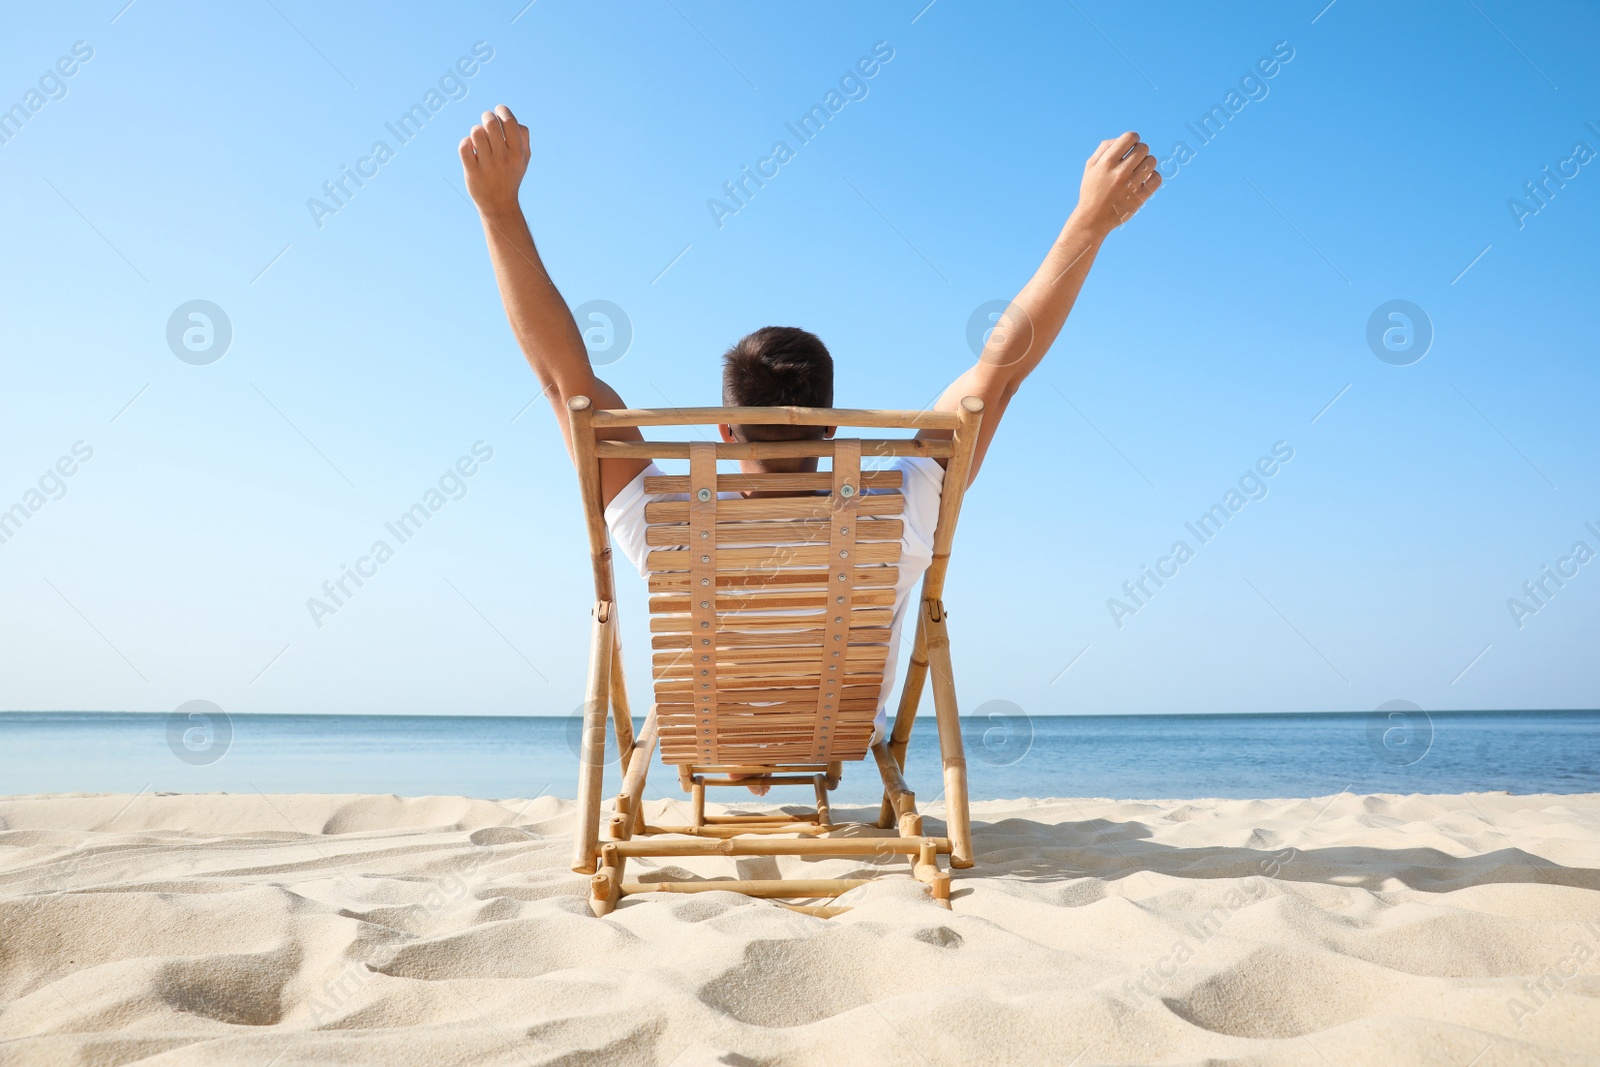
[0,712,1600,803]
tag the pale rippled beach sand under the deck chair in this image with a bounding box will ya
[0,793,1600,1067]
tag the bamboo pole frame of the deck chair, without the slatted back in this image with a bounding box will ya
[566,397,984,917]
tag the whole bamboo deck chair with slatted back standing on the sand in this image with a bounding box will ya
[568,397,982,917]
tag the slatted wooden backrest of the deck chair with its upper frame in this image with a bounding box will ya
[570,398,981,768]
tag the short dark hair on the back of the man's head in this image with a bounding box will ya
[722,326,834,440]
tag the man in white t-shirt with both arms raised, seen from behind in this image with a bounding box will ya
[461,106,1162,777]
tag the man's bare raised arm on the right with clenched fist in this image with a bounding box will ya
[918,133,1162,478]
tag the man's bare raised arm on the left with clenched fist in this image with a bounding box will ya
[461,104,645,504]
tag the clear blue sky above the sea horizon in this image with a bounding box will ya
[0,0,1600,713]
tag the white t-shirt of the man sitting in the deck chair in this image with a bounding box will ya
[605,456,944,741]
